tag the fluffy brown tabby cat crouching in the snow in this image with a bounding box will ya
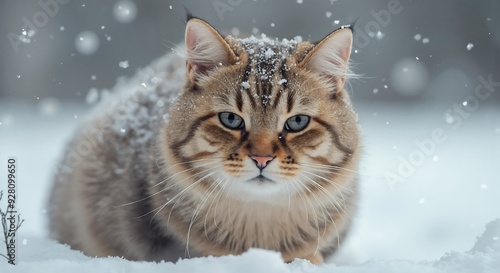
[49,16,361,264]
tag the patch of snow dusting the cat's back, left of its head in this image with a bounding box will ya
[88,50,185,148]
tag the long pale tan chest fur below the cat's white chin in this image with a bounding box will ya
[193,200,326,252]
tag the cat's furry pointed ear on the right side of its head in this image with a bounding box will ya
[301,27,353,93]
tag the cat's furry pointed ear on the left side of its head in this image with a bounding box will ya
[185,17,236,82]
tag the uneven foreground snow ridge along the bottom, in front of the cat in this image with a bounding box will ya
[2,220,500,273]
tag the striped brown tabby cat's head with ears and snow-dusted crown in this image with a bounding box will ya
[163,15,360,199]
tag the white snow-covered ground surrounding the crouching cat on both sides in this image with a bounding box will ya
[0,92,500,272]
